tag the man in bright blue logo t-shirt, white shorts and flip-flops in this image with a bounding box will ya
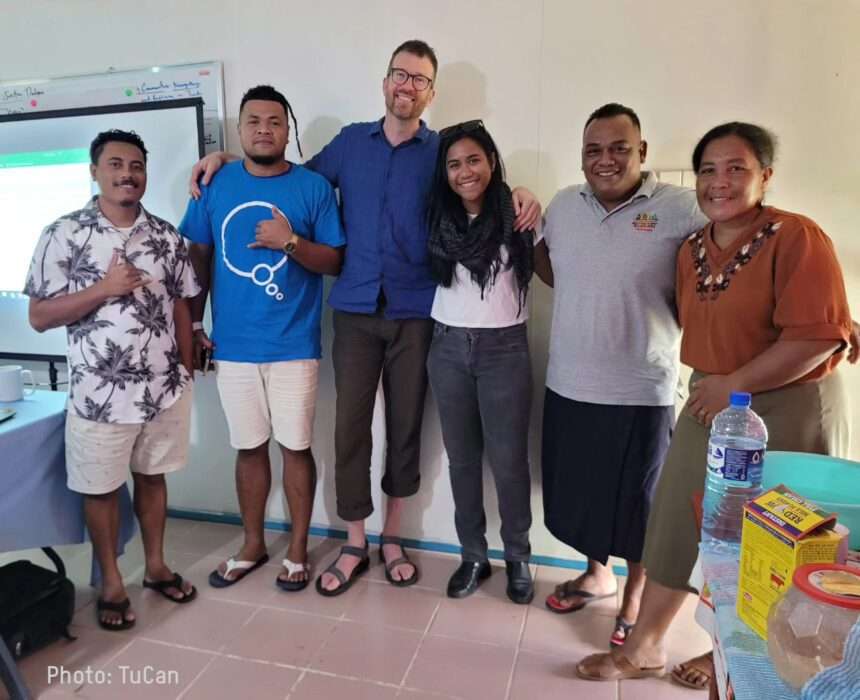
[180,85,346,591]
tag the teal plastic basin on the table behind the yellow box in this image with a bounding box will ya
[762,452,860,550]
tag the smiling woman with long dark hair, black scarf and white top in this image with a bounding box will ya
[427,120,534,604]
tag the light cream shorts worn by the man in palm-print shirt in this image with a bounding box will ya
[66,382,193,495]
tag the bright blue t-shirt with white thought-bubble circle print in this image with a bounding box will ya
[179,161,346,362]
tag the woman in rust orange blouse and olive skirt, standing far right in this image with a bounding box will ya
[577,122,851,687]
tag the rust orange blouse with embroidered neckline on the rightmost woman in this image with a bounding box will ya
[675,207,851,383]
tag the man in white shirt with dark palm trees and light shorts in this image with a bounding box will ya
[24,131,199,630]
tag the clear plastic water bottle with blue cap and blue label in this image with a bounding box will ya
[702,392,767,543]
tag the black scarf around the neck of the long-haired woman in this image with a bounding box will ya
[427,183,534,308]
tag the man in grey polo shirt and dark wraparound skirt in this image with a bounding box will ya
[535,104,705,644]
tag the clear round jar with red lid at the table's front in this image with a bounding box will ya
[767,564,860,690]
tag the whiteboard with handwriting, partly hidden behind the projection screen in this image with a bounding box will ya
[0,61,225,153]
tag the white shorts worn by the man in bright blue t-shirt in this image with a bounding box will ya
[216,360,320,450]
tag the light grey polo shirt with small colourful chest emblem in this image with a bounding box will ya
[544,173,707,406]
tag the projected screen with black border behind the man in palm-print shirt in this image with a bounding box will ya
[0,98,203,357]
